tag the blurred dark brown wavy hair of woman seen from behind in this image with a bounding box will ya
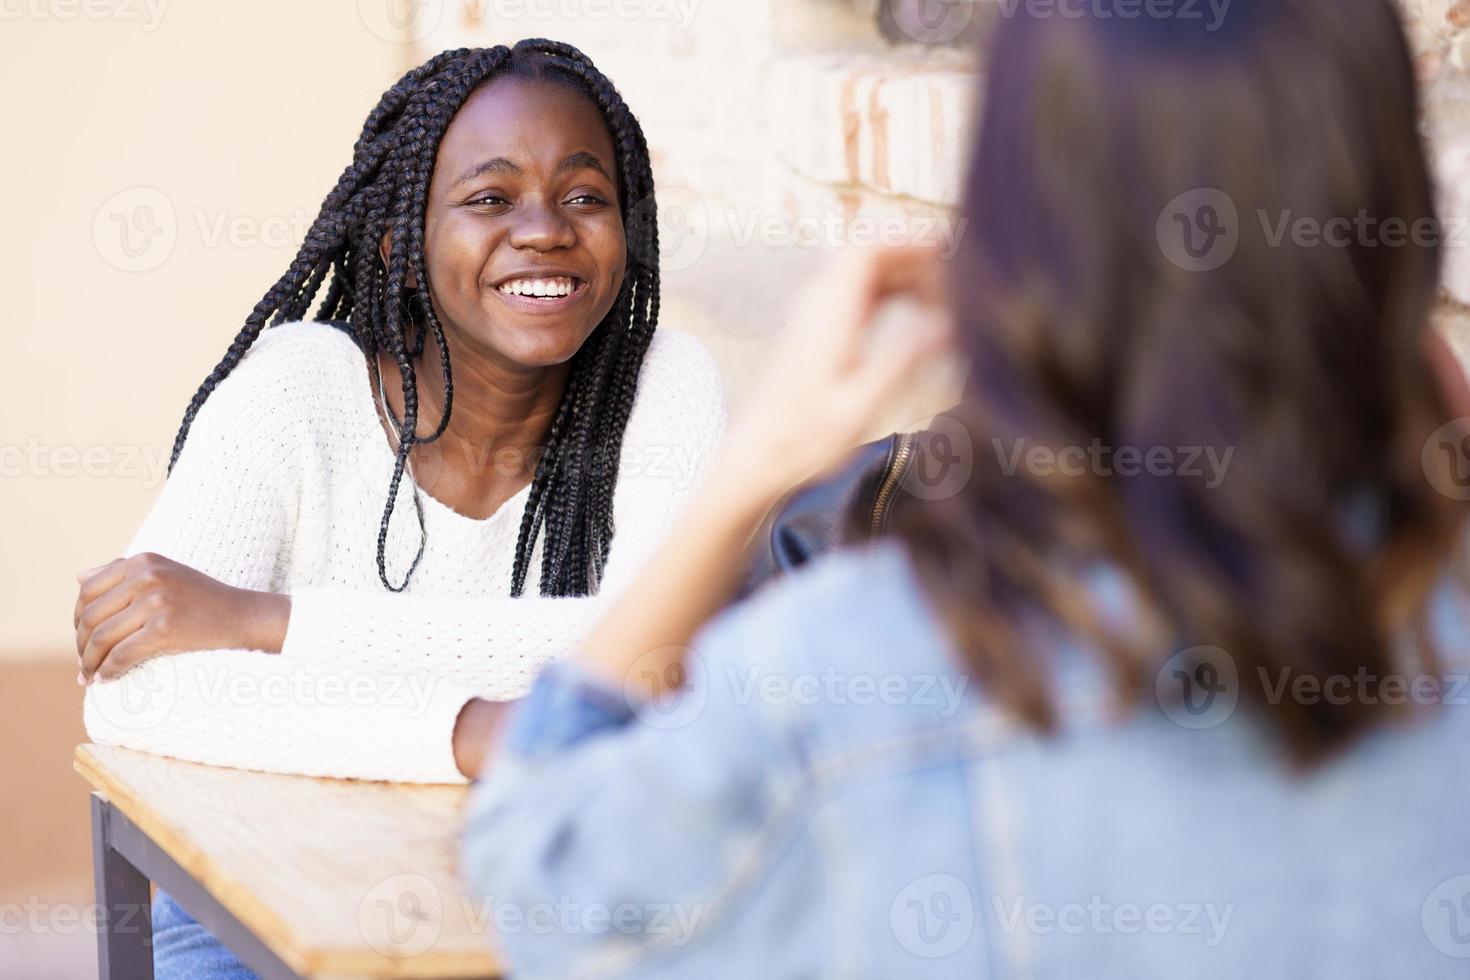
[898,0,1464,763]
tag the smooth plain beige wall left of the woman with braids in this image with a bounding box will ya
[0,0,412,657]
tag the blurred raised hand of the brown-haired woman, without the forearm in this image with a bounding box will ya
[728,238,950,495]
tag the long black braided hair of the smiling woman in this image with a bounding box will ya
[169,38,659,595]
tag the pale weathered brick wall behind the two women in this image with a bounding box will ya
[419,0,1470,399]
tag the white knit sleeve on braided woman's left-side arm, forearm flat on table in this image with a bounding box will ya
[82,328,475,782]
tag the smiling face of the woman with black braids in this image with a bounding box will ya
[423,78,628,369]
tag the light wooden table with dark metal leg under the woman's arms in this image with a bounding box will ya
[75,745,498,980]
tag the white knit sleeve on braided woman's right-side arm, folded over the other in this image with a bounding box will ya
[282,334,725,699]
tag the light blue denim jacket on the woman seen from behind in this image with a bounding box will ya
[463,545,1470,980]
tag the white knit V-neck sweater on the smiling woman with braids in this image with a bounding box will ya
[85,323,725,782]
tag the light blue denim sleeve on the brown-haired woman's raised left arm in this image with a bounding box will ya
[462,614,795,977]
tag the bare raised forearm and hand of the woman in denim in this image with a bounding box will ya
[573,248,950,701]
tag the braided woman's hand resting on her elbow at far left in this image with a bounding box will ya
[72,554,291,683]
